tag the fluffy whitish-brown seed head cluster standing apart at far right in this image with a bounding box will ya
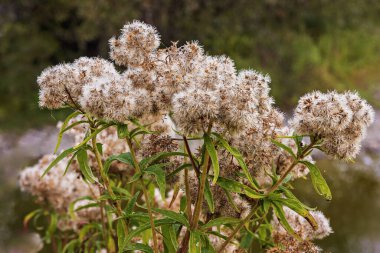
[291,91,374,159]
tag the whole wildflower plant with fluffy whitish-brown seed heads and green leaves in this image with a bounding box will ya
[20,21,374,253]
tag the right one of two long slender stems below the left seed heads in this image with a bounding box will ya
[126,138,159,253]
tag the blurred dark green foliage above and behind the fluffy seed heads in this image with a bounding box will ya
[0,0,380,128]
